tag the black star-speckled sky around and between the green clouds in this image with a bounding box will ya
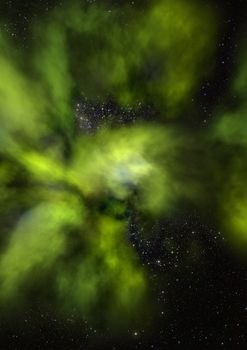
[0,0,247,350]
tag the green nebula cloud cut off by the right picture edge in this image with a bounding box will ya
[213,48,247,252]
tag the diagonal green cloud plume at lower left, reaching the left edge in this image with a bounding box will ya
[0,193,83,300]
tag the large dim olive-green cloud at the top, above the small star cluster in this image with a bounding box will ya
[63,0,216,114]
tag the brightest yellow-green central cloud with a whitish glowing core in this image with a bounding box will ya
[67,124,195,214]
